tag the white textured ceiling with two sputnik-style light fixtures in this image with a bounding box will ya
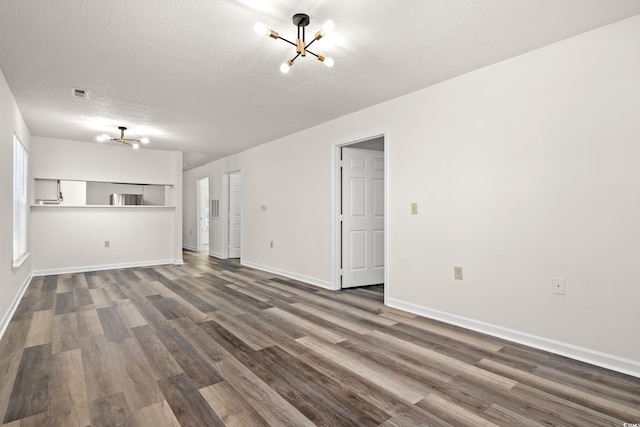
[0,0,640,169]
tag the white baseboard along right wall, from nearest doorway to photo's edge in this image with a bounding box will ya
[386,298,640,378]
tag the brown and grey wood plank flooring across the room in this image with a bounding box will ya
[0,252,640,427]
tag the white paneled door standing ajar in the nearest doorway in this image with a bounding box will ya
[342,147,384,288]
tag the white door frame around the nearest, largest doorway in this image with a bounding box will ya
[331,130,390,304]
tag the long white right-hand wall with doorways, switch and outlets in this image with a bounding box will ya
[185,16,640,376]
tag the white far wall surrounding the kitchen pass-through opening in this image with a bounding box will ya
[31,137,182,274]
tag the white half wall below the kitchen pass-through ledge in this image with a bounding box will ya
[31,206,181,275]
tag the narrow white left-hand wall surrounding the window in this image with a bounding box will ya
[0,70,32,336]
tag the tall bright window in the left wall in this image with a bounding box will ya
[13,134,27,267]
